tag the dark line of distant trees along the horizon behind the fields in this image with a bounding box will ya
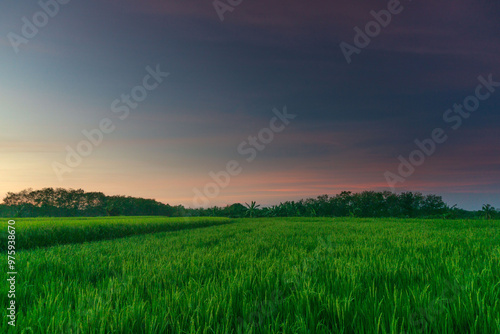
[0,188,500,219]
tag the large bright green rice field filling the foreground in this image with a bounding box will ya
[0,218,500,334]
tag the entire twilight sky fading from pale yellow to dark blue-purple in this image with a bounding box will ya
[0,0,500,210]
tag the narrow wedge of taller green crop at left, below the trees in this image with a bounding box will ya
[0,217,230,251]
